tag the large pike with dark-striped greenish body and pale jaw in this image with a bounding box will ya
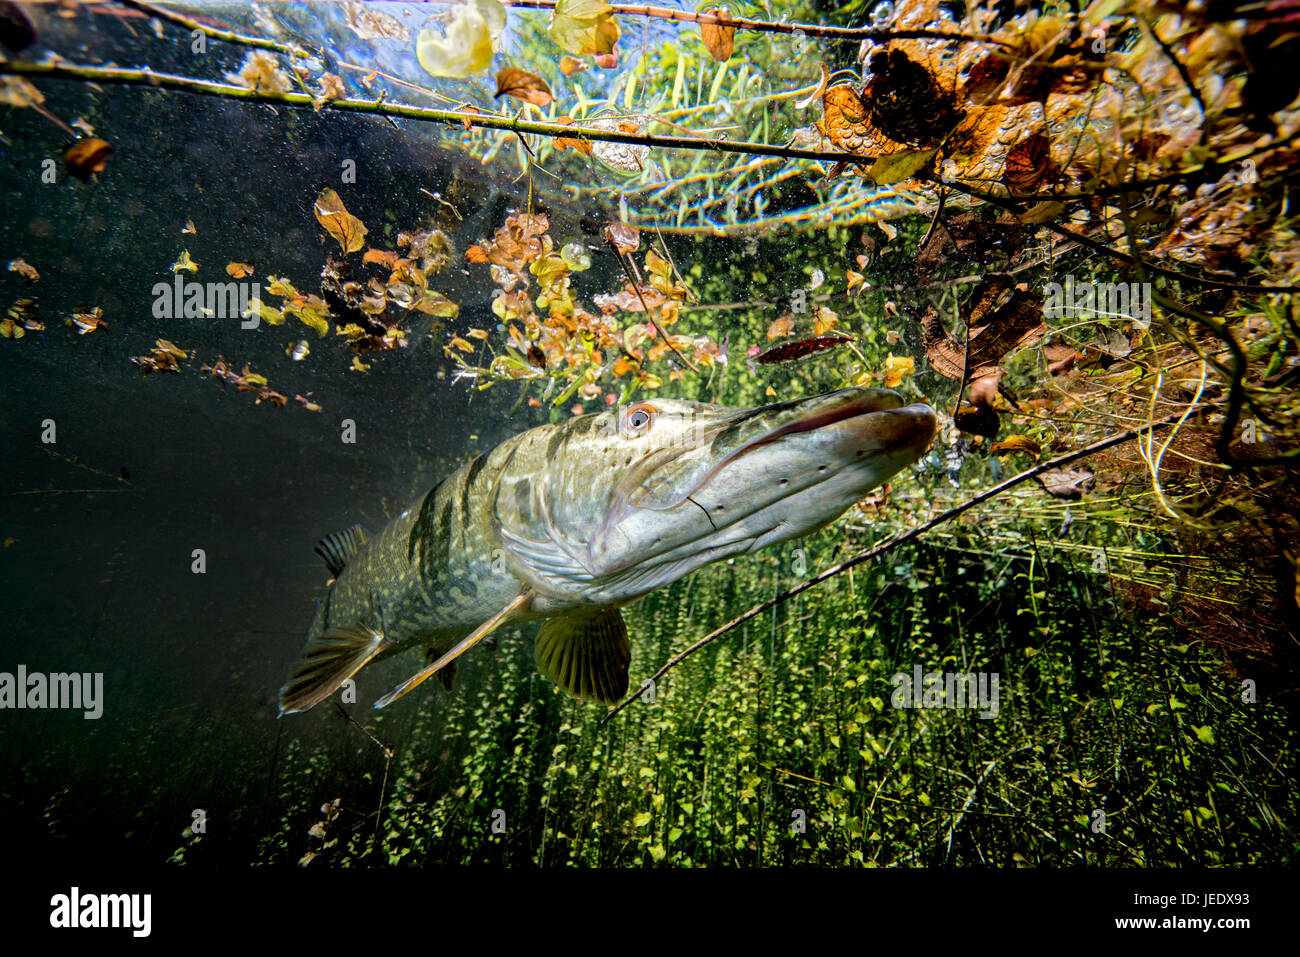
[280,387,936,716]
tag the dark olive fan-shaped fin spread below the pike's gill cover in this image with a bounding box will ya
[534,607,632,705]
